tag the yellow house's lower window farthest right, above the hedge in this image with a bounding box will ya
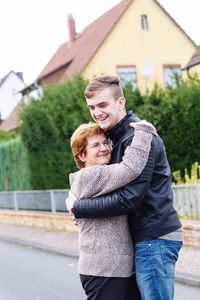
[163,66,181,87]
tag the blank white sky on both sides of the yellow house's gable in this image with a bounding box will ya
[0,0,200,84]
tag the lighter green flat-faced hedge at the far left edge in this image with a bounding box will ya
[0,138,31,191]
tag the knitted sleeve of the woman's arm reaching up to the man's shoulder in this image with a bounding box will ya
[70,125,153,199]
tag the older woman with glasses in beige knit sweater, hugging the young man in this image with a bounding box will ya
[70,122,155,300]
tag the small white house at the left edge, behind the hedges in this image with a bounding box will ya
[0,71,26,125]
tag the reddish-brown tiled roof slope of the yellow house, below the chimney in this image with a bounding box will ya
[37,0,132,81]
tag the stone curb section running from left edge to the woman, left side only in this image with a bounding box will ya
[0,235,79,259]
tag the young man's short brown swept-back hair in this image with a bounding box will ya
[85,75,124,100]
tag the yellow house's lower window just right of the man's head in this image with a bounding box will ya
[117,66,137,88]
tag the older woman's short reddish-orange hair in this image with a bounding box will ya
[70,123,104,169]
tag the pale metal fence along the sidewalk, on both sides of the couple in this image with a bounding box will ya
[0,184,200,219]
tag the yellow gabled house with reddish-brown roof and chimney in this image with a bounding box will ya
[37,0,197,90]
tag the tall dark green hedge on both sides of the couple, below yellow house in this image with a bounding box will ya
[18,76,200,189]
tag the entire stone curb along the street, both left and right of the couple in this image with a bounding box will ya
[0,235,200,287]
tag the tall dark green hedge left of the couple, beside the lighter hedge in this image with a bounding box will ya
[21,76,90,189]
